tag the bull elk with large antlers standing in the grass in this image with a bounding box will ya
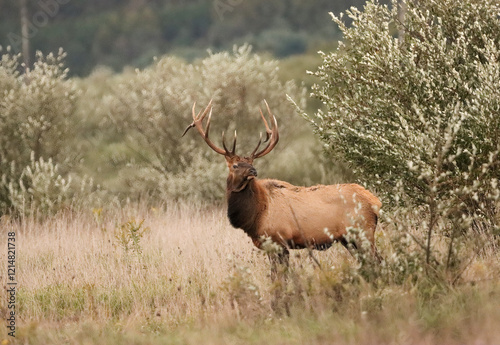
[182,101,382,280]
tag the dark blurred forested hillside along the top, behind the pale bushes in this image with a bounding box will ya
[0,0,376,76]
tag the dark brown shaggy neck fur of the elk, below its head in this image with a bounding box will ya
[226,179,266,239]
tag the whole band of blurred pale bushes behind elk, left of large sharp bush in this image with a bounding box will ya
[0,46,341,210]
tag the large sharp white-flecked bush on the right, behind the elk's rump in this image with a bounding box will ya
[308,0,500,273]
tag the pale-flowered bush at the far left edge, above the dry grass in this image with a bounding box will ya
[0,48,99,216]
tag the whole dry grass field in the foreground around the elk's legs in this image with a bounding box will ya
[0,205,500,345]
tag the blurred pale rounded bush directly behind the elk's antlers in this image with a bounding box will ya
[107,45,305,200]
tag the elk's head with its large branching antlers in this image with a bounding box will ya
[182,101,279,192]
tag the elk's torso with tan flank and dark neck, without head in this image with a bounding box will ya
[227,179,381,249]
